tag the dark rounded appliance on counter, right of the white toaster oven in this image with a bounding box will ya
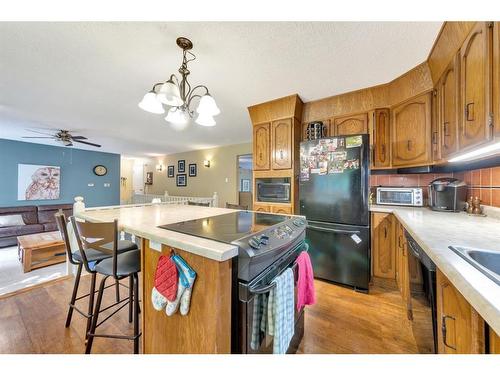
[429,177,467,212]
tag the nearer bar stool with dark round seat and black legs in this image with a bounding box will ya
[70,216,141,354]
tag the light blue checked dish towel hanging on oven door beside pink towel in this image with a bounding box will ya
[267,268,295,354]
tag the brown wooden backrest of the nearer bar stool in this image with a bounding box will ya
[70,216,118,277]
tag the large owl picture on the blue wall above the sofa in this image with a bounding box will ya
[17,164,61,201]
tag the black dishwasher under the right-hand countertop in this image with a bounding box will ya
[405,230,438,353]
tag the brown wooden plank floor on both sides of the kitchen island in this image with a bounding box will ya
[0,277,432,353]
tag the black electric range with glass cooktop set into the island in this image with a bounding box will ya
[160,211,307,353]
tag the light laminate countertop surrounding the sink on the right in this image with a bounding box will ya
[370,205,500,333]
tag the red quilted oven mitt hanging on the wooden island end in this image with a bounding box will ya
[151,255,178,311]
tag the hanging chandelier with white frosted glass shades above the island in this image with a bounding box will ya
[139,37,220,129]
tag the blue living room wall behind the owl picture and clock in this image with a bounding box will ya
[0,139,120,207]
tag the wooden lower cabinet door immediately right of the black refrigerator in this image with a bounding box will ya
[372,212,396,279]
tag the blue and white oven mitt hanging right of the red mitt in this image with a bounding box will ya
[165,255,196,316]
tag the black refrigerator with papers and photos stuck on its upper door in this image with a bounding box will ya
[299,134,370,291]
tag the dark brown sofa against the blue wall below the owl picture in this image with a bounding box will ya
[0,204,73,248]
